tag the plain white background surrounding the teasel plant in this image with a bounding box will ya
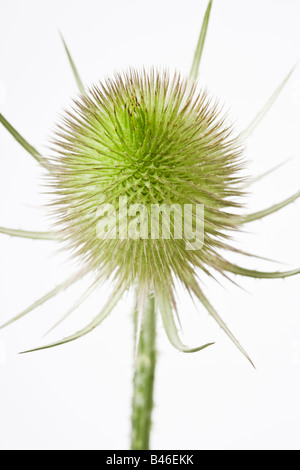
[0,0,300,449]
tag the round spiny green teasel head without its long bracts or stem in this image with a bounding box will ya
[50,70,242,298]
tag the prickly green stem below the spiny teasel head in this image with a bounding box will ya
[131,295,156,450]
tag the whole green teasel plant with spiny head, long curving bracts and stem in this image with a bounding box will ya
[0,0,300,450]
